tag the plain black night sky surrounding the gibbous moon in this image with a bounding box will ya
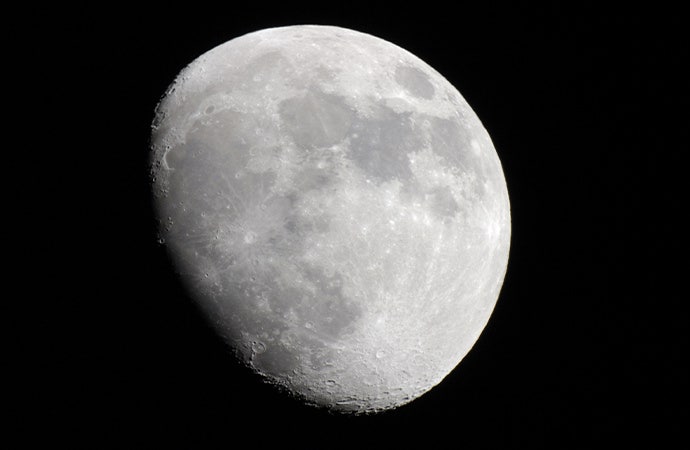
[26,2,690,448]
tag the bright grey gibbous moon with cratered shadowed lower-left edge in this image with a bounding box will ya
[150,26,510,413]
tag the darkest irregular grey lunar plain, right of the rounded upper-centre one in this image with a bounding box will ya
[350,106,423,183]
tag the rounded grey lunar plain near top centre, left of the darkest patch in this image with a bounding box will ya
[279,90,354,149]
